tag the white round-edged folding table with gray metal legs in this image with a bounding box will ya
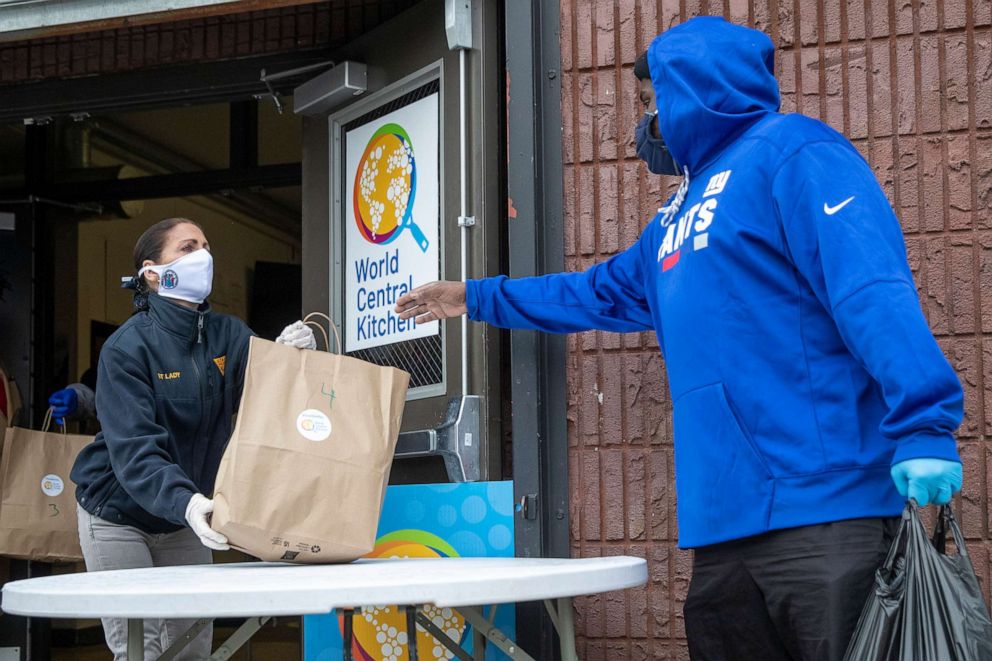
[2,556,647,661]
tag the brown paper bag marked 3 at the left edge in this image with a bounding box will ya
[0,410,93,562]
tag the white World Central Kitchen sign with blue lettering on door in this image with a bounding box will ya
[344,92,440,352]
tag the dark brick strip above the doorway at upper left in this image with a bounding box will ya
[0,0,414,85]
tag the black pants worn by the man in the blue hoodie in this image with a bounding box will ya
[685,517,899,661]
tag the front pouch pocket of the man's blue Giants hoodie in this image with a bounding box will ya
[674,383,775,547]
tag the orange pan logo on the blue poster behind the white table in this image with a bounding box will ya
[338,530,465,661]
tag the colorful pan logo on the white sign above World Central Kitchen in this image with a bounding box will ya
[353,124,430,252]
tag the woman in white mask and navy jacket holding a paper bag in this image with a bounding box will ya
[72,218,315,661]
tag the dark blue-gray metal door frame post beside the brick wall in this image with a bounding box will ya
[504,0,569,659]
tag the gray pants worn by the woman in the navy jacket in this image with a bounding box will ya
[77,507,213,661]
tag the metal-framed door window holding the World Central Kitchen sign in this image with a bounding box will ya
[328,67,447,400]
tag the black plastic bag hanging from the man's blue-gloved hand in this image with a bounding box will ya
[844,501,992,661]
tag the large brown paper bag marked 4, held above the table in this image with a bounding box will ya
[212,312,410,563]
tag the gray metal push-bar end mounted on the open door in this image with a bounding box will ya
[396,395,482,482]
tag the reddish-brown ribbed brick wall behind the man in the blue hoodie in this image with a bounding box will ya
[561,0,992,661]
